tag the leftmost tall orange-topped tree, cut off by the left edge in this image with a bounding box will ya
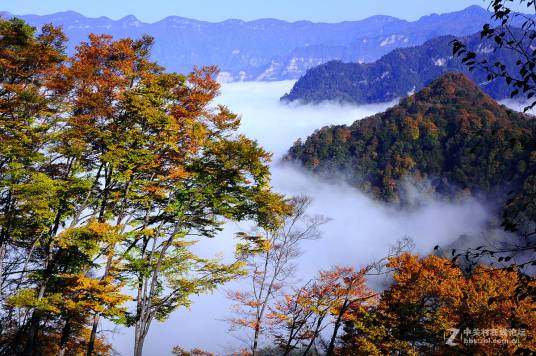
[0,19,65,300]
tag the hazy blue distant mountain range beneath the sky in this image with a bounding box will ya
[0,6,498,81]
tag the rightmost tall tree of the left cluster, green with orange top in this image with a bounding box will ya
[117,62,286,354]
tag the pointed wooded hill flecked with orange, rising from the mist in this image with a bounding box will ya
[286,73,536,227]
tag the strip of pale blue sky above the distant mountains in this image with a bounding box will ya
[0,0,528,22]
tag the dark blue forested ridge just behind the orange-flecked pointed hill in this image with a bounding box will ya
[282,30,517,104]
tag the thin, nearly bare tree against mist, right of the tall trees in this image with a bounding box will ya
[228,196,327,355]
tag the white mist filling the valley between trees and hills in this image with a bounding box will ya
[106,81,498,356]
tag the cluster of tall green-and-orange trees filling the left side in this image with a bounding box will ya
[0,20,288,355]
